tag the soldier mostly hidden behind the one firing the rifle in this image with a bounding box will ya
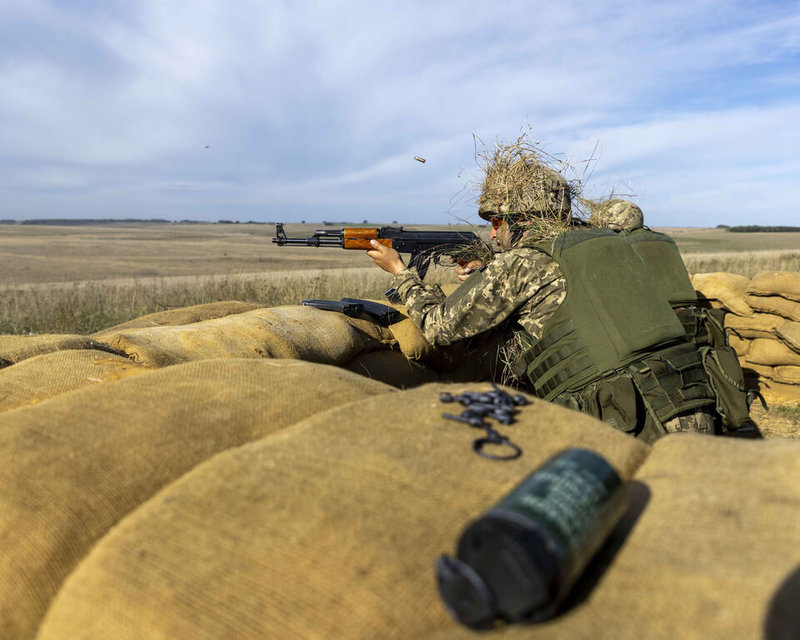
[586,198,760,437]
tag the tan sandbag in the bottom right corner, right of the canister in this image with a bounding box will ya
[420,434,800,640]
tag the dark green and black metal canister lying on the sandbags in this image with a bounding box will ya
[436,449,627,628]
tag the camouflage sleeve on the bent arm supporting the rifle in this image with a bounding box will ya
[392,248,563,345]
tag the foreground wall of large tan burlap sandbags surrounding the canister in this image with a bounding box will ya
[0,304,800,640]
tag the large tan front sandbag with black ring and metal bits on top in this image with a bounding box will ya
[39,384,648,640]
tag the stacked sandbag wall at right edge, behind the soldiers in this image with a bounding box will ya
[692,271,800,405]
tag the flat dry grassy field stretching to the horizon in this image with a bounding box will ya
[0,223,800,334]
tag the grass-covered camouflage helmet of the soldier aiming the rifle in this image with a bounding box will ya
[478,158,572,221]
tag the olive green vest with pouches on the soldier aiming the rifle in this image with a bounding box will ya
[513,229,714,433]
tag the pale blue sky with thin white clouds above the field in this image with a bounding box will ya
[0,0,800,226]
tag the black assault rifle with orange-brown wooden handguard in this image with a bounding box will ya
[272,222,483,278]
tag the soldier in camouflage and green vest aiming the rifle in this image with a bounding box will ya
[367,156,714,442]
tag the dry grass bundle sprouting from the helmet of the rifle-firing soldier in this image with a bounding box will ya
[478,135,580,244]
